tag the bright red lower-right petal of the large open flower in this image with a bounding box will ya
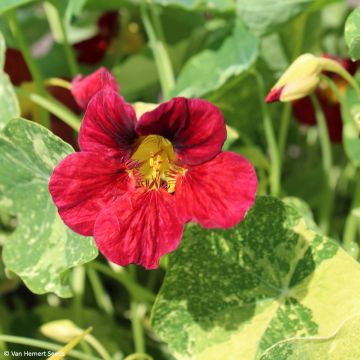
[175,152,257,228]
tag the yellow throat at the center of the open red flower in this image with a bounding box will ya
[131,135,176,192]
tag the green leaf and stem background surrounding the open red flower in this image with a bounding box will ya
[0,0,360,360]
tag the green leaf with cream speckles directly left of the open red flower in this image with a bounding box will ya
[0,119,97,297]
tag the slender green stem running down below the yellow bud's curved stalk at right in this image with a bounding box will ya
[310,94,334,234]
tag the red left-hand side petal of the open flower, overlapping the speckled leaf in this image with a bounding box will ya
[49,152,130,235]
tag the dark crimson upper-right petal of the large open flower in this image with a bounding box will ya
[136,97,226,165]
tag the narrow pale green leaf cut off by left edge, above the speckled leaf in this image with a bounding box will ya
[0,32,20,130]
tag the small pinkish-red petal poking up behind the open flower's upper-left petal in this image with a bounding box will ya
[71,67,119,110]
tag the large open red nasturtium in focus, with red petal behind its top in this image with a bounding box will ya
[49,70,257,269]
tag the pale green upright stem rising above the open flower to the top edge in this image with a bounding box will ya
[140,0,175,99]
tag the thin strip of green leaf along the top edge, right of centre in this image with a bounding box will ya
[155,0,235,11]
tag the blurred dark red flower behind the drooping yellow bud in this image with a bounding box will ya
[292,54,358,143]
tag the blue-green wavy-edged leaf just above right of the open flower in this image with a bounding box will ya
[173,22,258,97]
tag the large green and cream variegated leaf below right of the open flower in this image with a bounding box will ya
[152,197,360,360]
